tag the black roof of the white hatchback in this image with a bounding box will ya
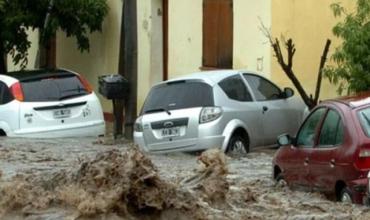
[3,69,75,81]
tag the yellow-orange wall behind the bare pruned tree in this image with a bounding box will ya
[271,0,355,99]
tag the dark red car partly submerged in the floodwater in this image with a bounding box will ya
[273,93,370,204]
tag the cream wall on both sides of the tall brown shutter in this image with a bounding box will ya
[168,0,271,78]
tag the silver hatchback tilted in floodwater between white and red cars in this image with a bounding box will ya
[134,70,307,153]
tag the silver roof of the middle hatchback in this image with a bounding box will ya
[160,70,265,86]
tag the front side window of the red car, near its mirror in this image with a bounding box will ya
[297,108,326,147]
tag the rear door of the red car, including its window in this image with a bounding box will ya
[309,109,344,191]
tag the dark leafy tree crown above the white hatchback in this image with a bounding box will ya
[0,0,108,72]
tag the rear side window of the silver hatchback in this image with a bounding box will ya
[218,75,252,102]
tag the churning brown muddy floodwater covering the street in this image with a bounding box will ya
[0,138,370,220]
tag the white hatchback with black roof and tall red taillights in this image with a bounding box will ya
[0,69,105,138]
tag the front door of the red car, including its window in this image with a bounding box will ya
[279,108,326,187]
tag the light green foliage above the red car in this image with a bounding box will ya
[325,0,370,94]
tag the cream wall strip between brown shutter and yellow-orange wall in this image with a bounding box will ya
[233,0,271,76]
